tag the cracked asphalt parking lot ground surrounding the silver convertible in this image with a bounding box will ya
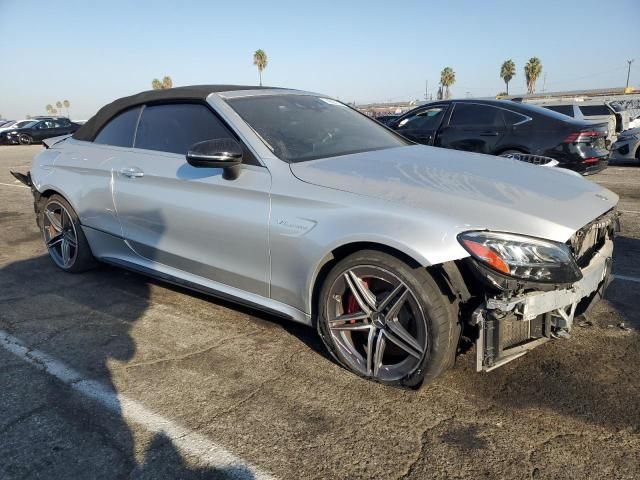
[0,146,640,480]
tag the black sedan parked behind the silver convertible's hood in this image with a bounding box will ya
[387,99,609,174]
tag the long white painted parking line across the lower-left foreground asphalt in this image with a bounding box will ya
[0,330,275,480]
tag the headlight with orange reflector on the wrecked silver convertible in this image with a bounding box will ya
[458,232,582,283]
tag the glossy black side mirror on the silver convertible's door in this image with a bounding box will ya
[187,138,242,180]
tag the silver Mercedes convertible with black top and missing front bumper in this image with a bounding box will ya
[15,85,618,387]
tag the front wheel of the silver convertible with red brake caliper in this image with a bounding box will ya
[317,250,460,388]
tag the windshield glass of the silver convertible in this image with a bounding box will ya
[227,95,410,162]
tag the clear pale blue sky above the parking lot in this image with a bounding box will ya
[0,0,640,119]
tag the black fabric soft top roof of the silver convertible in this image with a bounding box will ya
[73,85,273,142]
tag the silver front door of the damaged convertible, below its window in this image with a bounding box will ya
[115,149,271,296]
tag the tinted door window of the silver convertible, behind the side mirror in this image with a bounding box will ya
[135,103,235,155]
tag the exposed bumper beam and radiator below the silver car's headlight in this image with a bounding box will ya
[472,238,613,372]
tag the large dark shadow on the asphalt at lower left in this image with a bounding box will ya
[0,256,253,480]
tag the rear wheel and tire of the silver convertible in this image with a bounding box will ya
[38,195,97,273]
